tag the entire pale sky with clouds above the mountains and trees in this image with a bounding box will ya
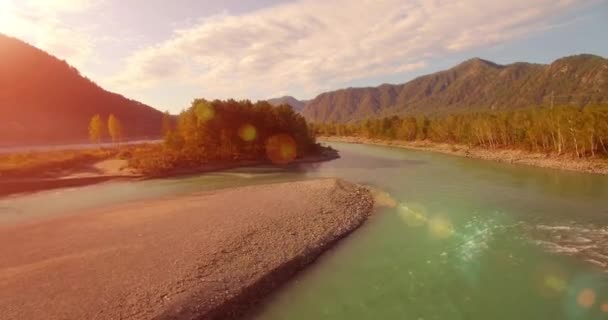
[0,0,608,112]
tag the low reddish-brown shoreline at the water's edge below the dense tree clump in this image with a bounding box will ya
[0,149,340,197]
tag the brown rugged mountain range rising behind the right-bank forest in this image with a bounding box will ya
[302,54,608,122]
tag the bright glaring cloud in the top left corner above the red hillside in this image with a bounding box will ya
[0,0,101,68]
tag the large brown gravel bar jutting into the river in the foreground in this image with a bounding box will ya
[0,179,373,320]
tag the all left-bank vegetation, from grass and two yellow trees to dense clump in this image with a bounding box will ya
[0,99,326,178]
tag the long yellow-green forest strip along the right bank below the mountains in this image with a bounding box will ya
[311,106,608,158]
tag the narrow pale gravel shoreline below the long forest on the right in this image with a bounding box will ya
[318,136,608,175]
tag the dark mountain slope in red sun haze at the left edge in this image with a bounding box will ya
[0,34,162,145]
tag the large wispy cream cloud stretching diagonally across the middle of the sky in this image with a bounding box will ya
[114,0,586,98]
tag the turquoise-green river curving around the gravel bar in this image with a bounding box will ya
[0,144,608,320]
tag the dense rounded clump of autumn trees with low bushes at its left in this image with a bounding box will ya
[130,99,319,173]
